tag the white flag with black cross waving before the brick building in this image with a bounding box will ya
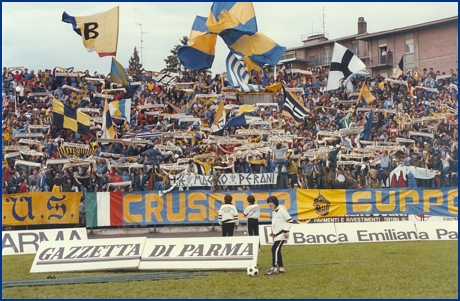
[326,43,366,91]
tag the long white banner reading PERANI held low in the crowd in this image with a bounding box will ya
[169,173,278,188]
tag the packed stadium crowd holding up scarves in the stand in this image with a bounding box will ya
[2,63,458,194]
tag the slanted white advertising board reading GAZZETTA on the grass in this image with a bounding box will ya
[30,237,146,273]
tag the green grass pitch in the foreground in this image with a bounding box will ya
[2,241,458,299]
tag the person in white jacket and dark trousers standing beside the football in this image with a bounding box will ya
[265,196,292,275]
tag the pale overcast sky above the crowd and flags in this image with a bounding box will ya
[2,2,458,74]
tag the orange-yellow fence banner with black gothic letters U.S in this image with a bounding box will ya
[2,192,82,226]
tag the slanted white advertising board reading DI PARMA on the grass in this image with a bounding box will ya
[139,236,259,270]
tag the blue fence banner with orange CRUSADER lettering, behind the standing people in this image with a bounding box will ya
[122,190,297,225]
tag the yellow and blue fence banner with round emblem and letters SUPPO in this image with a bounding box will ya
[297,187,458,220]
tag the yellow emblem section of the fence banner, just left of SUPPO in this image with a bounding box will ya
[297,189,347,220]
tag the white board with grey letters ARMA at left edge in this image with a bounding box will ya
[2,228,88,256]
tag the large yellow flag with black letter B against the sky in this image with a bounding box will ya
[62,6,119,57]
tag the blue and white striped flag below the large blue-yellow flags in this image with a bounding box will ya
[225,52,262,92]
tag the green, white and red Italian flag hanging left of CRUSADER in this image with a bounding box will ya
[85,192,123,228]
